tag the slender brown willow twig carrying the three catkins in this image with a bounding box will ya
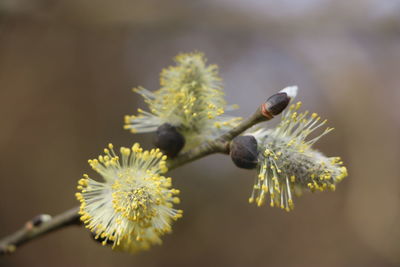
[0,93,289,255]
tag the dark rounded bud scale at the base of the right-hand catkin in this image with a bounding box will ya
[230,135,258,169]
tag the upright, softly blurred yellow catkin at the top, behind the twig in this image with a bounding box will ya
[124,53,240,151]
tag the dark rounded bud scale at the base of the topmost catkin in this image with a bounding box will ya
[154,123,185,158]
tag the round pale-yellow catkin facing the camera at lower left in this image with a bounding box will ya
[76,144,182,251]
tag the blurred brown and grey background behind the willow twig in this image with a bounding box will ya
[0,0,400,267]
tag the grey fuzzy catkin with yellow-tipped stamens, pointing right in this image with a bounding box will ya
[249,102,347,211]
